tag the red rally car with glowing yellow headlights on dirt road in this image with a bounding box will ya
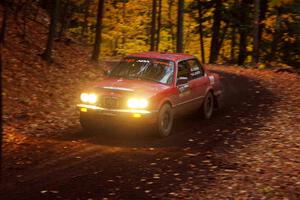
[77,52,221,137]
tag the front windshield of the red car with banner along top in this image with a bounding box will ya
[110,57,174,84]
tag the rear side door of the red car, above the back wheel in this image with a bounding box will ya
[187,58,209,107]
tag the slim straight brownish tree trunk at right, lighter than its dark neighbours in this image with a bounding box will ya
[252,0,260,65]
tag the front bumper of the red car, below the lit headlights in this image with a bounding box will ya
[77,104,158,124]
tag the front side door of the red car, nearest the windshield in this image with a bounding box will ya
[174,60,192,115]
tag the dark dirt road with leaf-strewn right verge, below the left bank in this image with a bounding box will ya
[0,66,300,199]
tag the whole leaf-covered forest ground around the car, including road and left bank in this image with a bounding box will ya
[0,8,300,199]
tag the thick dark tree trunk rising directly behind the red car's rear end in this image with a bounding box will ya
[209,0,222,63]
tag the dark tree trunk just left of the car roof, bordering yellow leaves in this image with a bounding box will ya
[92,0,104,61]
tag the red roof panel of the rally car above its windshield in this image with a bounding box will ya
[126,51,195,62]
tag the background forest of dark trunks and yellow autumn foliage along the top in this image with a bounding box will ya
[1,0,300,68]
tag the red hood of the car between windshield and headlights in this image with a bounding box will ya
[86,78,170,98]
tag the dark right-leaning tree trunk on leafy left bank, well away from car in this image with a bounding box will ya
[42,0,60,63]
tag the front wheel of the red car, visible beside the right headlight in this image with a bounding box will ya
[157,104,174,137]
